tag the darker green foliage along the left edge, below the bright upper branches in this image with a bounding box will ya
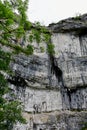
[0,49,25,130]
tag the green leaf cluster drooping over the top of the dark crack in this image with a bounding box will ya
[29,22,55,55]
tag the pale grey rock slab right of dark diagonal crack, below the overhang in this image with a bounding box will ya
[52,33,87,88]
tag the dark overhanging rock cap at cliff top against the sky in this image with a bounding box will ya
[49,14,87,34]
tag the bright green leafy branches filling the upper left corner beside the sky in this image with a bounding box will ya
[0,0,33,54]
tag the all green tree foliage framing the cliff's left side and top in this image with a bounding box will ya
[0,0,54,130]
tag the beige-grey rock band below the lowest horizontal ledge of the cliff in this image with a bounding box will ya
[14,111,87,130]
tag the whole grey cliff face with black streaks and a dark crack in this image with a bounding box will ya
[8,14,87,130]
